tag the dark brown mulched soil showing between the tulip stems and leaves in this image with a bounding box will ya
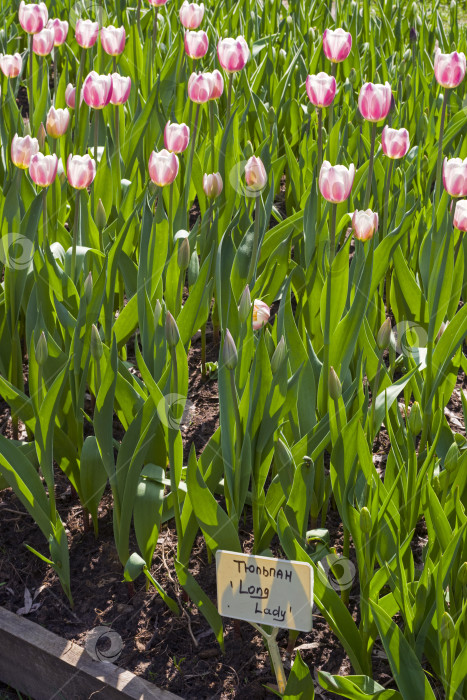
[0,329,465,700]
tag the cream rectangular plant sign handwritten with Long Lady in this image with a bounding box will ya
[216,549,313,632]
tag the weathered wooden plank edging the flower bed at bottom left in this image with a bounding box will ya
[0,606,182,700]
